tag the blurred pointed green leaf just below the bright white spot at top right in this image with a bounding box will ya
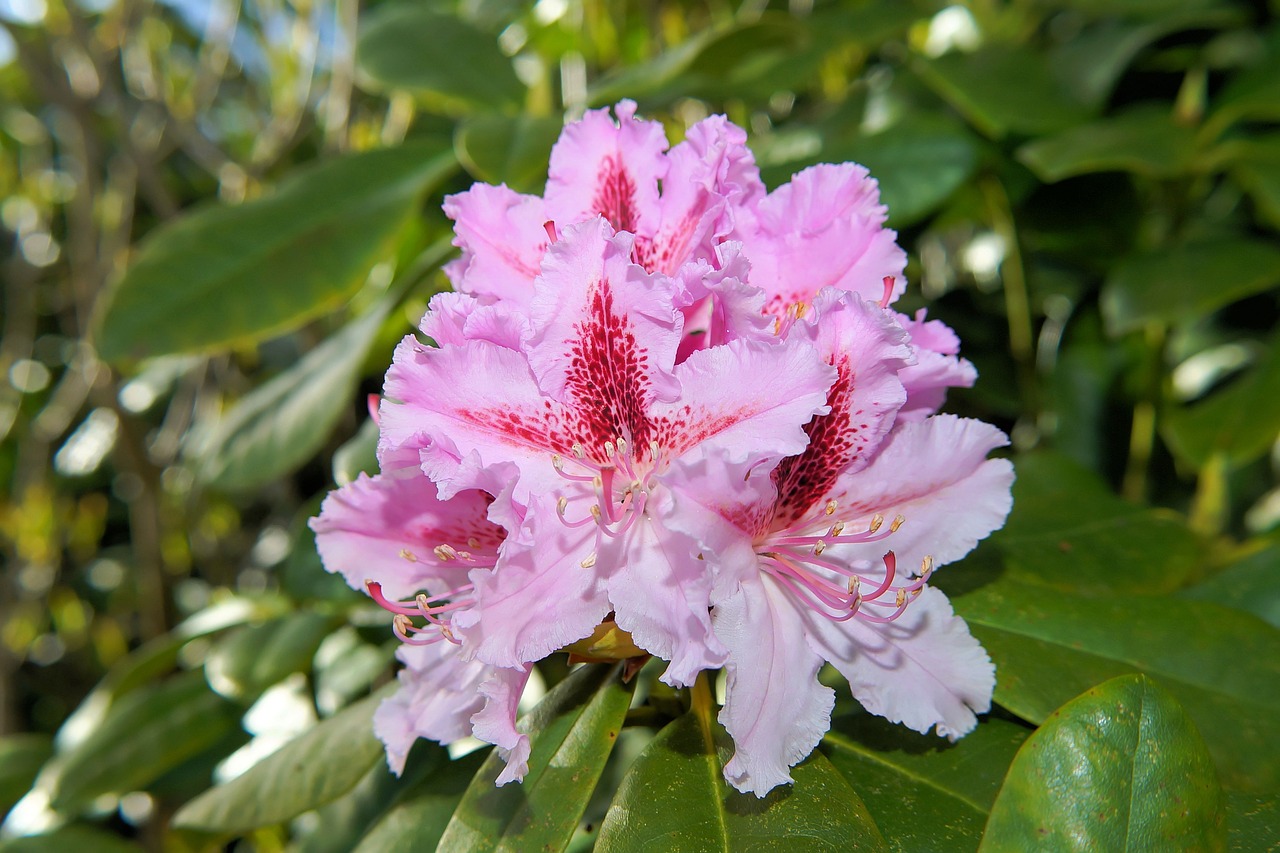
[913,47,1091,140]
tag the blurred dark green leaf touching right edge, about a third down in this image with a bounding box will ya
[1102,237,1280,334]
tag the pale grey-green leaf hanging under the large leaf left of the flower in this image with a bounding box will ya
[193,298,390,492]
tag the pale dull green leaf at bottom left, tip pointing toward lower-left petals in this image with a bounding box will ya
[173,690,388,835]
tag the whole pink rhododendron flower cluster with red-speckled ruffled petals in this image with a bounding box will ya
[312,101,1012,797]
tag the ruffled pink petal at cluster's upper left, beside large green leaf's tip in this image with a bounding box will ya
[444,183,547,307]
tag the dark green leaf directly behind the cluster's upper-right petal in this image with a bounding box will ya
[823,117,978,228]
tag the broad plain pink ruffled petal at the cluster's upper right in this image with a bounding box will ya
[737,163,906,311]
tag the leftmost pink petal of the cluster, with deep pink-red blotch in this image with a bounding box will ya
[310,469,503,598]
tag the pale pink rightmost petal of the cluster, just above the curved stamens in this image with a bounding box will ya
[833,415,1014,571]
